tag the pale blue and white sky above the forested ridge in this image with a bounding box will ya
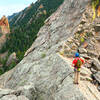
[0,0,37,18]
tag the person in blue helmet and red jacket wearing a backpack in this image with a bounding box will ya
[72,52,84,84]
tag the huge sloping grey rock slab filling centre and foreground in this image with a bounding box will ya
[0,0,100,100]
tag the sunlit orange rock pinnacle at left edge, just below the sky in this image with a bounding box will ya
[0,16,10,34]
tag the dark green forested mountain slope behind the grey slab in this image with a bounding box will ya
[0,0,64,73]
